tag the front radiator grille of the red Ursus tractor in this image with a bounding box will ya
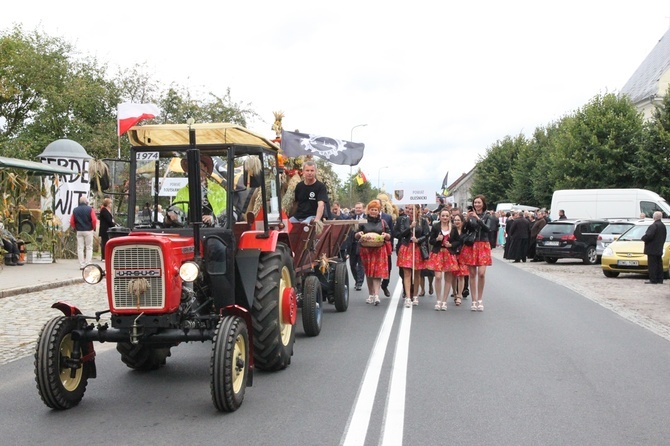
[112,245,165,309]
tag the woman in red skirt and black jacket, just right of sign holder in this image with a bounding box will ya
[426,208,460,311]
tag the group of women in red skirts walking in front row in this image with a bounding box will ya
[348,195,495,311]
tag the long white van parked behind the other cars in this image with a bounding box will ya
[550,189,670,220]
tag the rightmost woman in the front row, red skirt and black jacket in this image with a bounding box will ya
[461,195,493,311]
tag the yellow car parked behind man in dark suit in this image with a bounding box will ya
[600,219,670,279]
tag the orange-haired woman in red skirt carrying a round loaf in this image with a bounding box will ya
[354,200,391,305]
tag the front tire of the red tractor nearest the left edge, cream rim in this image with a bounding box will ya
[34,316,93,410]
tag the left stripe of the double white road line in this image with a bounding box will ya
[340,286,402,446]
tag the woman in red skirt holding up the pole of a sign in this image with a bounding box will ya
[396,205,430,307]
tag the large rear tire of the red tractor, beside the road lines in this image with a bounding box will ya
[251,243,295,371]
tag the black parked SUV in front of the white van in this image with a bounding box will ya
[537,220,609,265]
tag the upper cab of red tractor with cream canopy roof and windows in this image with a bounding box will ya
[128,123,280,229]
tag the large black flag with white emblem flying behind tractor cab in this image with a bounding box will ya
[281,130,365,166]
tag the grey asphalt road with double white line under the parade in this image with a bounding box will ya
[0,260,670,445]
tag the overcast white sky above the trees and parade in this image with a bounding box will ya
[0,0,670,189]
